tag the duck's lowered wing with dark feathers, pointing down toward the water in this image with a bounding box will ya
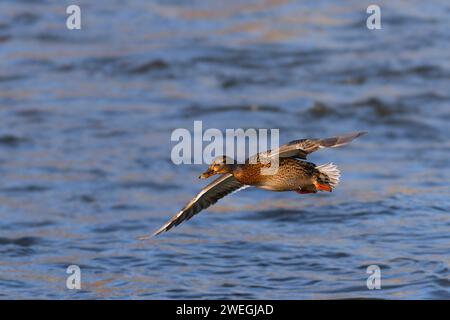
[147,173,246,239]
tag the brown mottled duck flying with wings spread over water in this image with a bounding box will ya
[149,131,367,239]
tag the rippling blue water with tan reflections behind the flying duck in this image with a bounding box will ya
[0,0,450,299]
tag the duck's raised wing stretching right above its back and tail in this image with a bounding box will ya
[262,132,367,159]
